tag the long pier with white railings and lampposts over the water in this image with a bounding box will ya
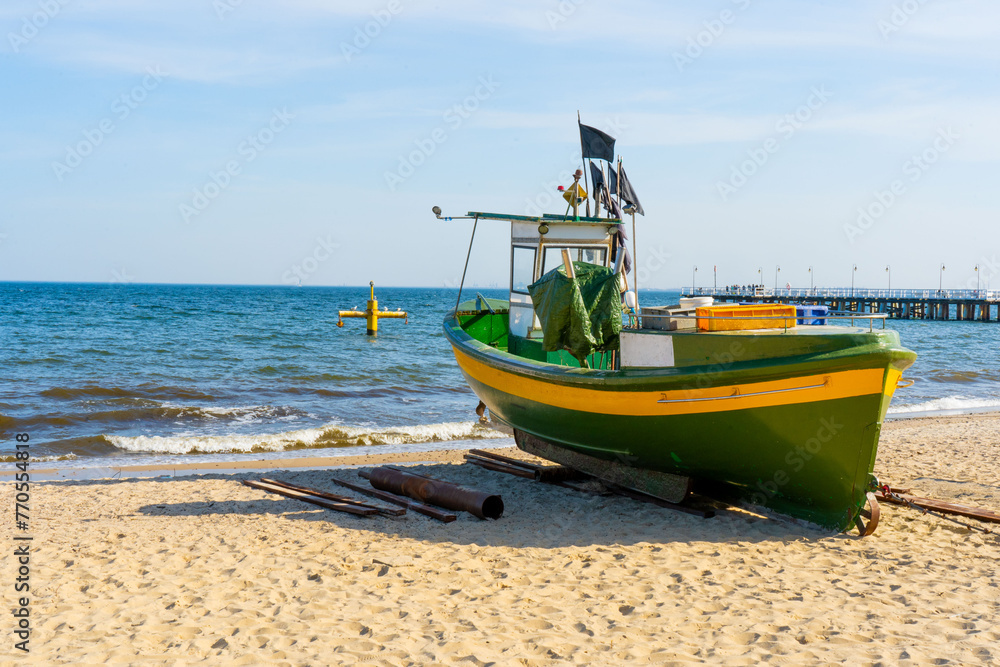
[681,287,1000,322]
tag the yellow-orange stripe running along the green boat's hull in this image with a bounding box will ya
[452,345,884,417]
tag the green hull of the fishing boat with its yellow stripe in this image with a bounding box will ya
[444,311,916,530]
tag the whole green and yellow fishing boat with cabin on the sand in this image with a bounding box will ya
[434,126,916,535]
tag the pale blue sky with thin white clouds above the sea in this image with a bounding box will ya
[0,0,1000,289]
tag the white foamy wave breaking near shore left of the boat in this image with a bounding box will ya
[104,422,508,454]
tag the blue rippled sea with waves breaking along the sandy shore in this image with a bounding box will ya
[0,283,1000,469]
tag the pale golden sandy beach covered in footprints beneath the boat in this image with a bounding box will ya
[7,414,1000,665]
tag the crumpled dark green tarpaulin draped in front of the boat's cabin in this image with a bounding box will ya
[528,262,622,366]
